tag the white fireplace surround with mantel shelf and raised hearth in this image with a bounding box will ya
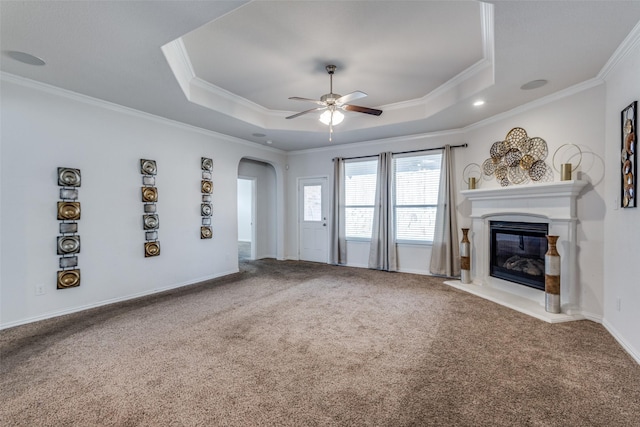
[446,181,587,323]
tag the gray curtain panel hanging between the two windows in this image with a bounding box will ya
[369,152,398,271]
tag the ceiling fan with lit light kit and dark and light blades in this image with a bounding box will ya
[287,65,382,142]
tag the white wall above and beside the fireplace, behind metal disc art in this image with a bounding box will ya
[458,84,605,321]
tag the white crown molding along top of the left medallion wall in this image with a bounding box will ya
[0,71,286,154]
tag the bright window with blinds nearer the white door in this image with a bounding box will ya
[344,159,378,239]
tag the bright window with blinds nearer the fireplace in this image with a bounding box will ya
[394,153,442,243]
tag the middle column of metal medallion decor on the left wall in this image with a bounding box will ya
[140,159,160,258]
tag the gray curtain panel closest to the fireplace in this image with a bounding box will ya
[429,145,460,277]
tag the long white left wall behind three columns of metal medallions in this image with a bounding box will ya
[0,75,285,327]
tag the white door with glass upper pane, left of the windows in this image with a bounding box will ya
[298,178,329,262]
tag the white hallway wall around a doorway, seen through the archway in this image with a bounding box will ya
[238,158,278,259]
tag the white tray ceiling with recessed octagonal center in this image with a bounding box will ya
[0,0,640,150]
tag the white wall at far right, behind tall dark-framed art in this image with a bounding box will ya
[603,27,640,362]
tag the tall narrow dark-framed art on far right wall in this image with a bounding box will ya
[620,101,638,208]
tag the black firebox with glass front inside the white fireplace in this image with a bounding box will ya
[489,221,549,290]
